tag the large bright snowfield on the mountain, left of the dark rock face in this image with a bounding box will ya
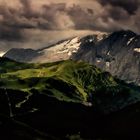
[33,37,81,62]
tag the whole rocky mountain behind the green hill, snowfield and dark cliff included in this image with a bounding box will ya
[4,30,140,84]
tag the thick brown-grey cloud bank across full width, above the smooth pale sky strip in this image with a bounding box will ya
[0,0,140,41]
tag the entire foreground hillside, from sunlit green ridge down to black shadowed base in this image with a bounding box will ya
[0,58,140,139]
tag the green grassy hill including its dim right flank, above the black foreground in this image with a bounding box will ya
[0,58,140,113]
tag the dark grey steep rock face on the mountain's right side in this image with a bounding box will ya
[72,31,140,84]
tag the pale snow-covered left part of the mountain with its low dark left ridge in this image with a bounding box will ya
[3,33,105,63]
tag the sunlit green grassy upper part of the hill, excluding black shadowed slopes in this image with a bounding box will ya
[0,57,117,101]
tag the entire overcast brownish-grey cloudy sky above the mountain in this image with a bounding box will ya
[0,0,140,52]
